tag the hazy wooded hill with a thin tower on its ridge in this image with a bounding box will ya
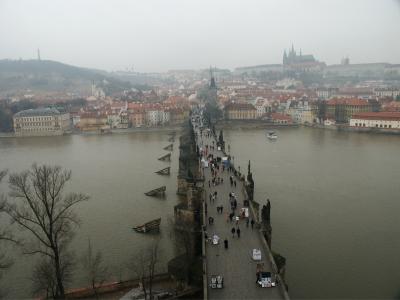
[0,60,130,95]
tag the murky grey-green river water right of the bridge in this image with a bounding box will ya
[224,128,400,299]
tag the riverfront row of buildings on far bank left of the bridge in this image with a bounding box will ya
[13,96,190,136]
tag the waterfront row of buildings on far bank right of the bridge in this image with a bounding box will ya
[224,98,400,129]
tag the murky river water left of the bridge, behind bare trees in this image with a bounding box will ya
[0,132,179,298]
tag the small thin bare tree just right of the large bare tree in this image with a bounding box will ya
[81,240,108,299]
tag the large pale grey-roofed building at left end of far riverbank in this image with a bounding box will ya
[13,108,71,136]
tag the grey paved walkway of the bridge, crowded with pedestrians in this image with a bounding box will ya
[197,116,285,299]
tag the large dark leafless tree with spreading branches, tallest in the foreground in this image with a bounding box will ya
[5,164,88,298]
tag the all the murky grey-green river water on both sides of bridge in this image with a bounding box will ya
[0,128,400,299]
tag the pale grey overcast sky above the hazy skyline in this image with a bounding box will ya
[0,0,400,72]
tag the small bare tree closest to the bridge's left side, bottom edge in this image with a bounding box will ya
[130,239,159,299]
